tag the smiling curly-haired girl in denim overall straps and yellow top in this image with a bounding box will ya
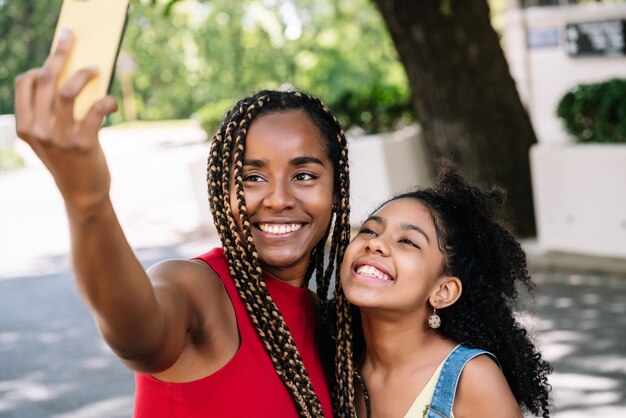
[341,163,552,418]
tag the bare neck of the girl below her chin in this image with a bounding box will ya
[361,310,452,373]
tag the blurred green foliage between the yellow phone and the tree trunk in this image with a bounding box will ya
[147,0,412,134]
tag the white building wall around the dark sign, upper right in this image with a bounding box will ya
[503,3,626,144]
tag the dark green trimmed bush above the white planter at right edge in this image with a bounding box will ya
[557,79,626,143]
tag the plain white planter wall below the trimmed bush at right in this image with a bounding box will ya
[530,144,626,257]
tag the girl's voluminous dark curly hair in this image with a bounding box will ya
[353,160,552,417]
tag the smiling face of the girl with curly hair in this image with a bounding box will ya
[341,198,444,315]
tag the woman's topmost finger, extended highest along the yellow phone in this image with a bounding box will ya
[34,29,73,139]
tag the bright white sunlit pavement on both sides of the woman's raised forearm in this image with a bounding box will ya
[0,127,211,280]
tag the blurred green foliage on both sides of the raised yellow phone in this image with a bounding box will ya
[0,0,411,134]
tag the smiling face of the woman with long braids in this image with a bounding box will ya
[230,110,334,284]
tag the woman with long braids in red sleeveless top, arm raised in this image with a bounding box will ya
[15,33,352,418]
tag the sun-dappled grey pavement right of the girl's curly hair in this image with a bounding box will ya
[530,269,626,418]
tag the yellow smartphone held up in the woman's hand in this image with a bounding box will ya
[52,0,130,119]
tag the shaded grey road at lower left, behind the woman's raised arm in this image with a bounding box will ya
[0,242,208,418]
